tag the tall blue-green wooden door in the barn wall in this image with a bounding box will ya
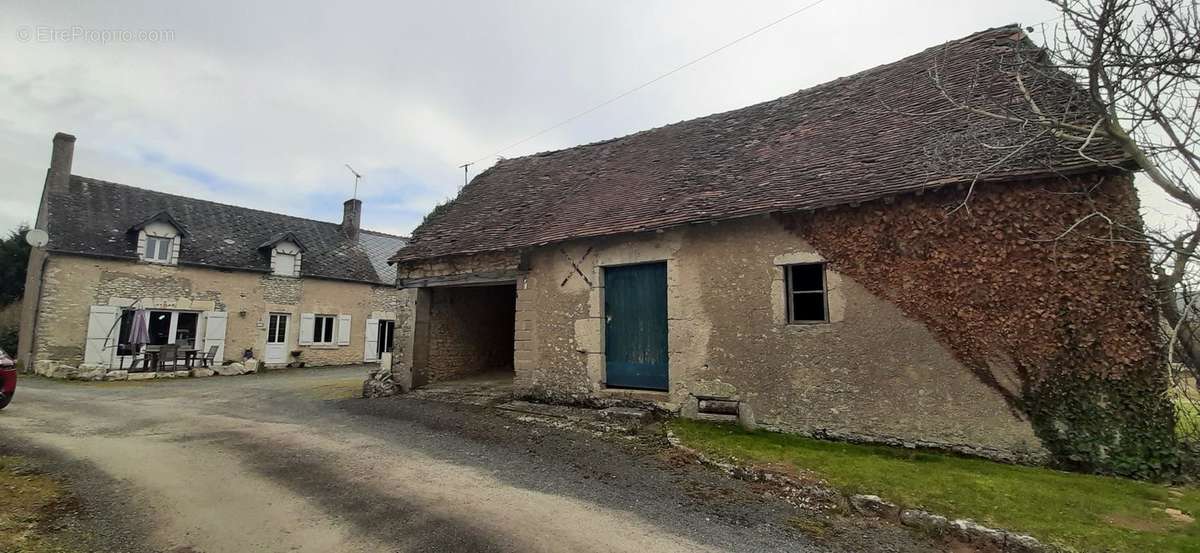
[604,263,667,390]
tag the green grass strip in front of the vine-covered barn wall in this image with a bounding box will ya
[671,420,1200,553]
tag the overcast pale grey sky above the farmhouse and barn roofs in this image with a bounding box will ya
[0,0,1180,234]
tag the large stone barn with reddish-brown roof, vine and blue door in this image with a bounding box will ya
[392,28,1160,461]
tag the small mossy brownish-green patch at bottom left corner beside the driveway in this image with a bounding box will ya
[0,456,78,553]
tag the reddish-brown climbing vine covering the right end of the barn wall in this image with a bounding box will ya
[776,174,1176,477]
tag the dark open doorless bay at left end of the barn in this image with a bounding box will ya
[413,283,517,386]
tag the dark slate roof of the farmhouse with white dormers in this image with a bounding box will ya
[46,175,407,284]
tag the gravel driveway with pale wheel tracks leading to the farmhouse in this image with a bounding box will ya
[0,367,932,553]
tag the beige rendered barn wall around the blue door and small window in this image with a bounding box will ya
[517,217,1039,456]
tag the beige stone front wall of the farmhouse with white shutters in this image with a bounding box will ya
[23,254,412,366]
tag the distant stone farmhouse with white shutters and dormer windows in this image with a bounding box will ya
[18,133,410,378]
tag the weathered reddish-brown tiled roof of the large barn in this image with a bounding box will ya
[392,26,1124,262]
